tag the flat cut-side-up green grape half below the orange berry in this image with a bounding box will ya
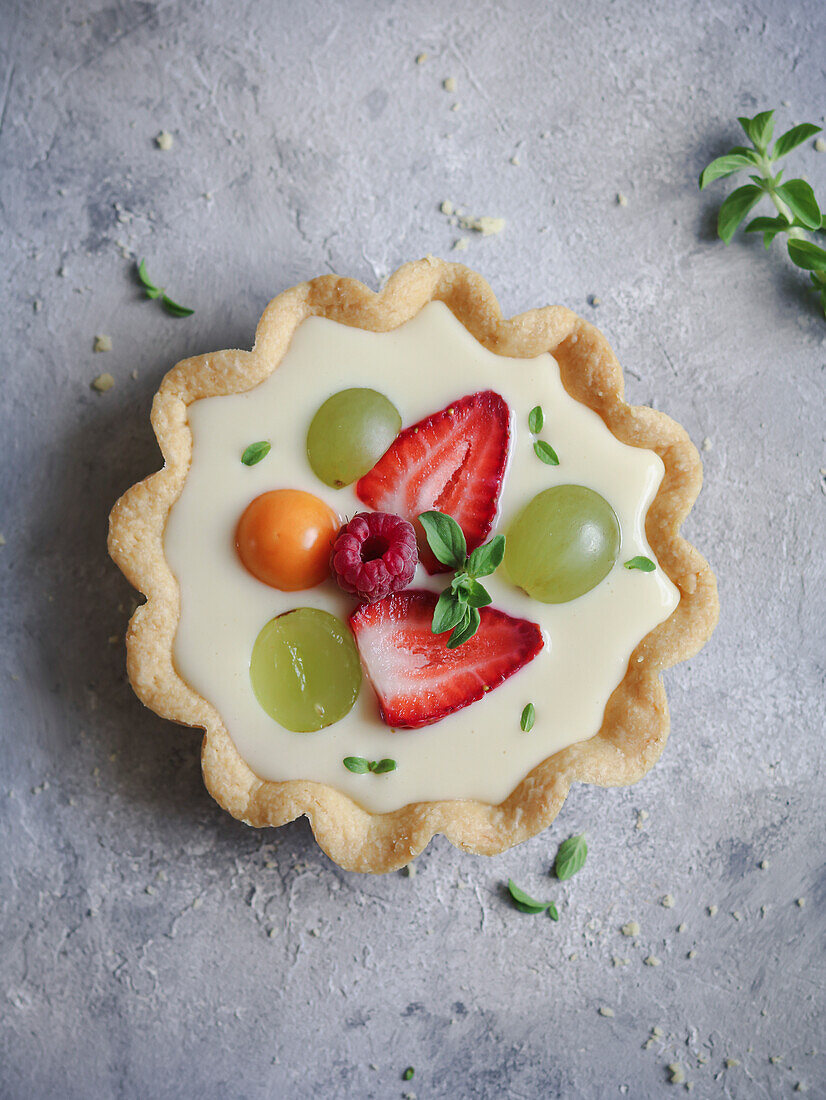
[250,607,362,734]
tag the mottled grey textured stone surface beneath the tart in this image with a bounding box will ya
[0,0,826,1100]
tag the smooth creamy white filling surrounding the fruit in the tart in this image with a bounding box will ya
[165,303,680,813]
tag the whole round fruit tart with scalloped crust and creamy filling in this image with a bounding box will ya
[109,257,717,872]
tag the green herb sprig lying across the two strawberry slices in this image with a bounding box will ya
[419,512,505,649]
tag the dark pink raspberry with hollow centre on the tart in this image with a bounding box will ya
[330,512,419,604]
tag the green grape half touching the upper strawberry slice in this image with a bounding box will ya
[307,389,401,488]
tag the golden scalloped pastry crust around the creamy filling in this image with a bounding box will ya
[109,257,718,873]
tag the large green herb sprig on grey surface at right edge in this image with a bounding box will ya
[700,111,826,316]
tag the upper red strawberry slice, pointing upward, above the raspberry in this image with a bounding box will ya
[355,389,510,573]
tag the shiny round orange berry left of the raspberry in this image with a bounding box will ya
[235,488,341,592]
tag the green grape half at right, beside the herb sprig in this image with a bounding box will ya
[505,485,619,604]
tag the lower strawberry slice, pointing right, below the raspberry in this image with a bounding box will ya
[350,591,544,729]
